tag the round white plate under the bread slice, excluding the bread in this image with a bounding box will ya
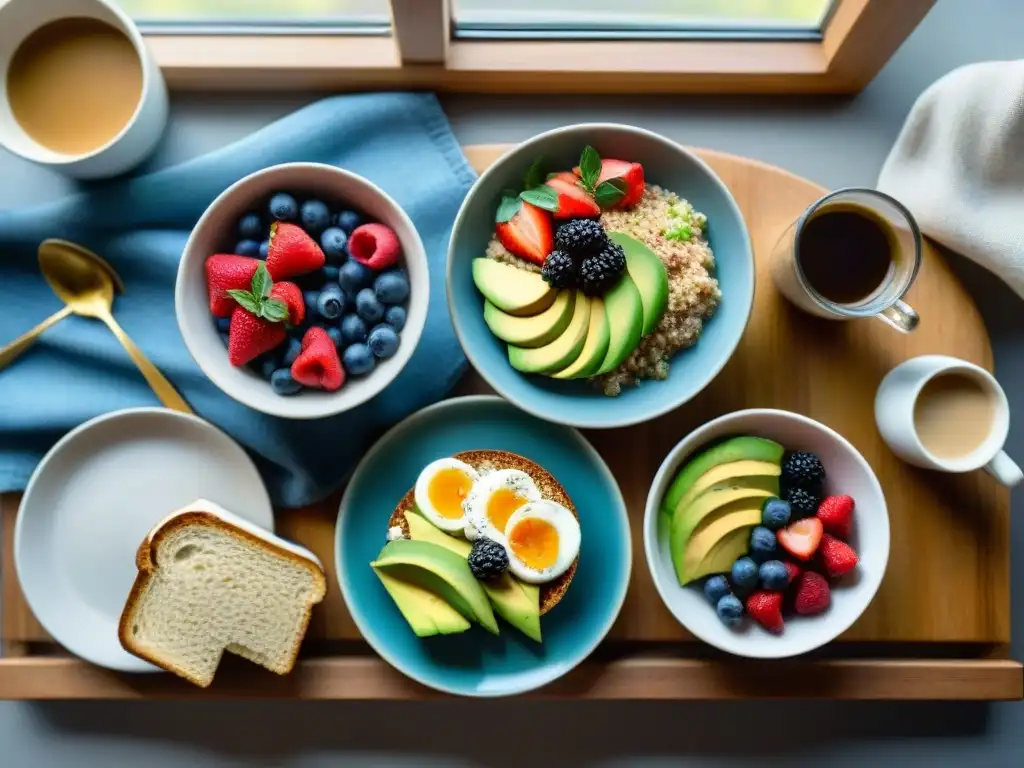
[14,408,273,672]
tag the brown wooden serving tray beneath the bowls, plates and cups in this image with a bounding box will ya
[0,145,1024,699]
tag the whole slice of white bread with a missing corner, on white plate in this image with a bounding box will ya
[118,500,327,687]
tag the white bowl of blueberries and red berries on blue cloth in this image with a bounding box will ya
[174,163,429,419]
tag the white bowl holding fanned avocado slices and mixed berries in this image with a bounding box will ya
[644,409,889,658]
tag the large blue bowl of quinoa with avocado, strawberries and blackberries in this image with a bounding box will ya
[446,123,755,428]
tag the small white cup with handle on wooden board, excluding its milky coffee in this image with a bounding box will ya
[874,354,1024,487]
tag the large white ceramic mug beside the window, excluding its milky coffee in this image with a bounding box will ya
[0,0,168,179]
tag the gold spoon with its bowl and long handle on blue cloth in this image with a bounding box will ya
[39,240,193,414]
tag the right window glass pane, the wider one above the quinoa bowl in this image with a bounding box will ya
[455,0,833,36]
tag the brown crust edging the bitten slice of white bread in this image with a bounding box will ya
[118,510,327,688]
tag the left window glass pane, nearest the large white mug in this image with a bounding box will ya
[120,0,390,27]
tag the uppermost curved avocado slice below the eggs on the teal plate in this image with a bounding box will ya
[371,539,499,635]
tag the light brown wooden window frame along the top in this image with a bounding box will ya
[145,0,935,93]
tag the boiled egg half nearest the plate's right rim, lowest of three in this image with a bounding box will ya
[505,499,580,584]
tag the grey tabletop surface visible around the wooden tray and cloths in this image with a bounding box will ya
[0,0,1024,768]
